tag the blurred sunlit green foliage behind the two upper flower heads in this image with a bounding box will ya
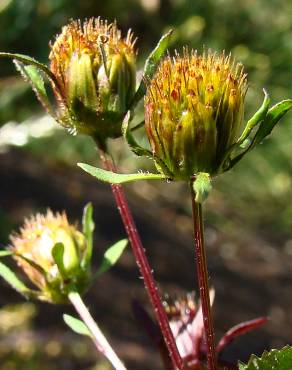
[0,0,292,234]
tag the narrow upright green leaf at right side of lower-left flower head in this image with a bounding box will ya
[81,203,95,269]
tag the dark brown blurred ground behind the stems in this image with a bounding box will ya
[0,150,292,370]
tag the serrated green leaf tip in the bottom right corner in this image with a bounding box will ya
[239,346,292,370]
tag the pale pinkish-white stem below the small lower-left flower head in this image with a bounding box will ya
[68,292,126,370]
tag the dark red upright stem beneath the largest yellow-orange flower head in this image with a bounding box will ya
[190,180,216,370]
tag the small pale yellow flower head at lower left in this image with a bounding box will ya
[10,210,89,303]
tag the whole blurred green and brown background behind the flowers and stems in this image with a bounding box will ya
[0,0,292,370]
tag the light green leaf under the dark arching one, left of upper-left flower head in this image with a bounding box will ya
[14,60,57,119]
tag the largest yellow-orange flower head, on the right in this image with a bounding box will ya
[145,51,247,180]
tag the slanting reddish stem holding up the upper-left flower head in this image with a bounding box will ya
[100,149,184,370]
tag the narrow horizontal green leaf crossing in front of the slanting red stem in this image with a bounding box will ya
[77,163,167,184]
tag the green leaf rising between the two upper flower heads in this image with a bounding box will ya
[130,30,173,109]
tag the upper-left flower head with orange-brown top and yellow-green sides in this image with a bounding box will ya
[49,18,136,140]
